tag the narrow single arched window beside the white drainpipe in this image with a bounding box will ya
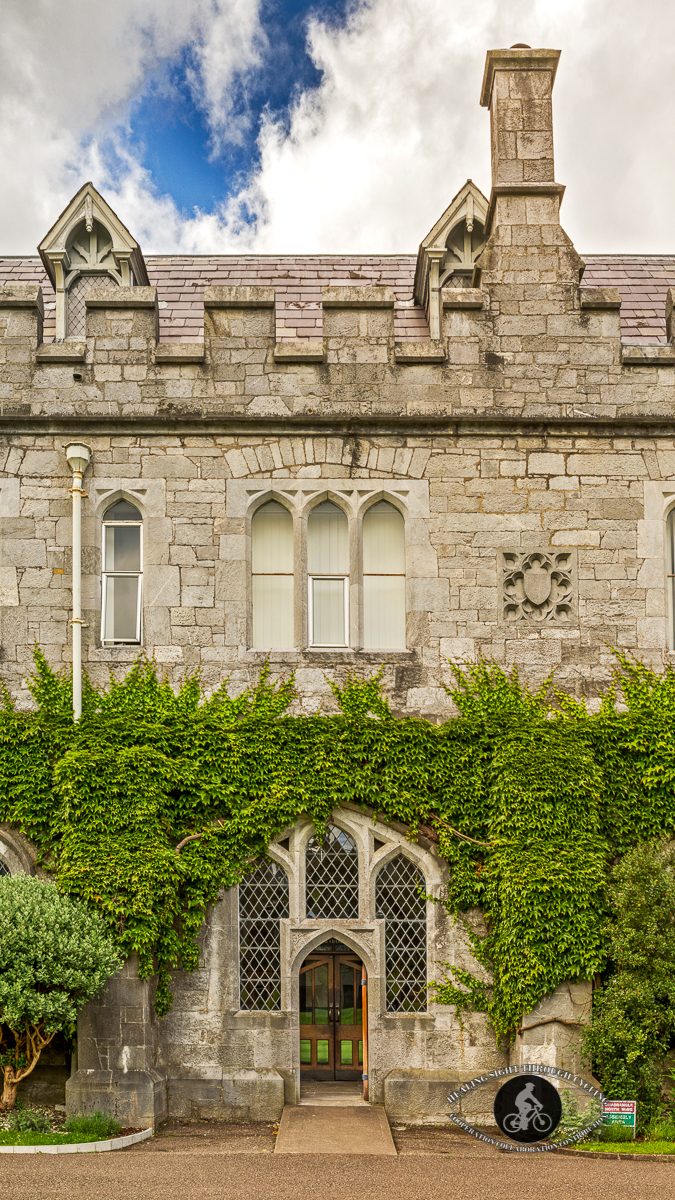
[101,500,143,646]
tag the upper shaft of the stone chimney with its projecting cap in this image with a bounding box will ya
[480,47,560,191]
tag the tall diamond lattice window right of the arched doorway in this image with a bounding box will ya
[375,854,426,1013]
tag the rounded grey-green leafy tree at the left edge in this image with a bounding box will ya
[0,875,121,1110]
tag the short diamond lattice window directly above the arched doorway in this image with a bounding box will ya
[305,824,359,920]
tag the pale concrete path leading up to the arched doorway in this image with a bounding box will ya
[274,1104,396,1158]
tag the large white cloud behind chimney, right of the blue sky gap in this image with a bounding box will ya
[229,0,675,253]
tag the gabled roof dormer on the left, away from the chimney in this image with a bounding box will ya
[37,184,149,342]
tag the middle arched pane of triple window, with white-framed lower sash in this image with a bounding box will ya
[307,500,350,646]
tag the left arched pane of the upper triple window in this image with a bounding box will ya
[251,500,294,650]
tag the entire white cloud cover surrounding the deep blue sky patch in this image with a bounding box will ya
[0,0,675,253]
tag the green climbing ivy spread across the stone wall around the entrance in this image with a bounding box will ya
[0,652,675,1080]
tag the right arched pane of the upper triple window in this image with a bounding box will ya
[363,500,406,650]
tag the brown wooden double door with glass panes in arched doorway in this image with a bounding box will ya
[300,942,365,1080]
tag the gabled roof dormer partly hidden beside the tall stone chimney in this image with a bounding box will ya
[414,179,488,340]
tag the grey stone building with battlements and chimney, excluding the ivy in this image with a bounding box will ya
[0,48,675,1120]
